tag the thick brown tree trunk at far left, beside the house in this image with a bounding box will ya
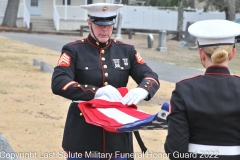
[2,0,20,27]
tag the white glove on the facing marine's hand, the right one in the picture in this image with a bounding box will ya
[121,88,148,105]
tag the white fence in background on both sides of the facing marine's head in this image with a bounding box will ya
[53,5,226,31]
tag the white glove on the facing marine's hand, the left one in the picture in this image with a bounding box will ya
[94,85,122,100]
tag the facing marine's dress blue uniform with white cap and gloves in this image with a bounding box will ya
[52,3,160,159]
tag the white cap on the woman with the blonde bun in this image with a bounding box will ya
[188,20,240,46]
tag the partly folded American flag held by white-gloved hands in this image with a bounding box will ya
[78,88,169,132]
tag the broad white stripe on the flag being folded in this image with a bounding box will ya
[98,108,139,124]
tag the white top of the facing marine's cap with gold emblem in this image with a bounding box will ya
[81,3,123,18]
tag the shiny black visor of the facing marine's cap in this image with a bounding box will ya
[89,15,116,26]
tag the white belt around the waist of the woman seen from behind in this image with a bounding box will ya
[188,143,240,155]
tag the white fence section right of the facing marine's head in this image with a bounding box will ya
[120,8,226,31]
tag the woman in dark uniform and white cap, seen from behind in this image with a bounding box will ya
[165,20,240,160]
